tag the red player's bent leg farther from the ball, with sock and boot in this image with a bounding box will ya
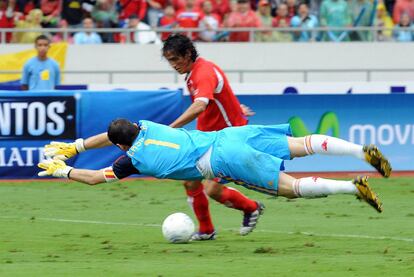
[204,180,265,236]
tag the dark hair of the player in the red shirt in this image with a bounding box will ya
[162,34,198,62]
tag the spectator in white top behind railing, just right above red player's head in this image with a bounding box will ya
[198,0,220,42]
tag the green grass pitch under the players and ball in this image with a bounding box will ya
[0,178,414,277]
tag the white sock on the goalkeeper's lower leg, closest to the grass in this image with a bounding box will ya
[293,177,358,198]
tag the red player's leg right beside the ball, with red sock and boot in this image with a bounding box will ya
[184,181,216,240]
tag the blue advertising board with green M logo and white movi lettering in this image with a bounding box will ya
[238,94,414,172]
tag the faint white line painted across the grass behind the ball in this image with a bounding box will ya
[0,216,414,243]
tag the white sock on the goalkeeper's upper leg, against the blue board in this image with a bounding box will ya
[304,135,365,160]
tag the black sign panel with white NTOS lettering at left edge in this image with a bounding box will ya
[0,96,76,140]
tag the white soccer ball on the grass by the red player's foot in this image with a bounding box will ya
[162,213,194,243]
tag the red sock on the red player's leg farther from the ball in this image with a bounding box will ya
[219,186,257,213]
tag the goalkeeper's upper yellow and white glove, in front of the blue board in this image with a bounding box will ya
[44,139,86,161]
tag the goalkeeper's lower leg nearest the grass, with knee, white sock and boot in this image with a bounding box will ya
[278,172,382,212]
